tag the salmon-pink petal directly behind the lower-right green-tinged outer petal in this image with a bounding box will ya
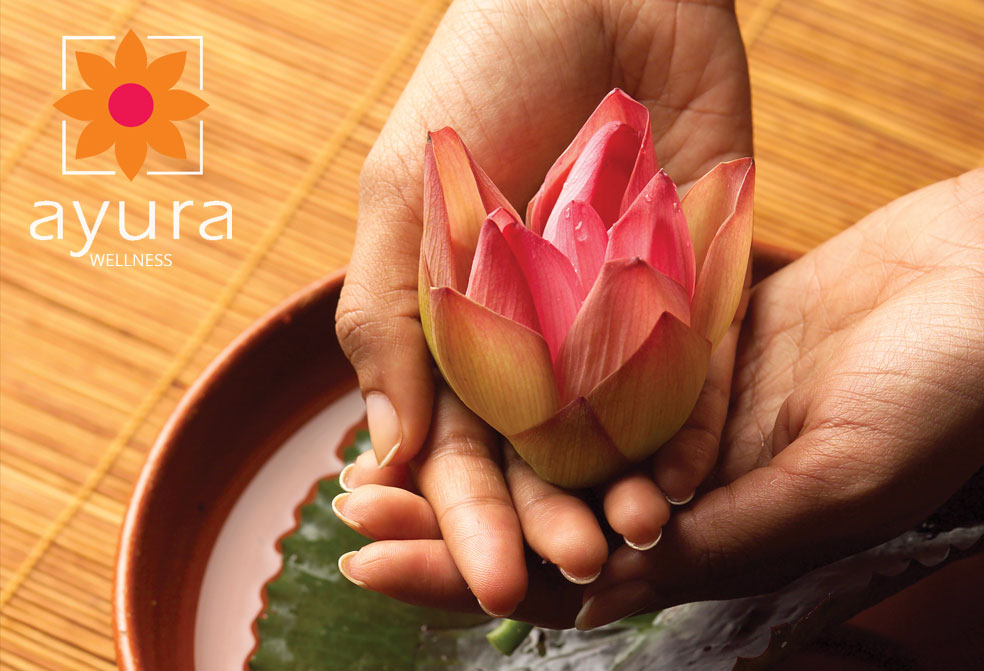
[554,258,690,403]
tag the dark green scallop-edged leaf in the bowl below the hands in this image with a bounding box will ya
[250,432,984,671]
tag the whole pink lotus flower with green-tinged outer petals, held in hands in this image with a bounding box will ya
[419,89,755,487]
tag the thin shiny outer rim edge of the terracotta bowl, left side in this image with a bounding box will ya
[112,267,347,671]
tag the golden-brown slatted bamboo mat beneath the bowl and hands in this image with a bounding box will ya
[0,0,984,671]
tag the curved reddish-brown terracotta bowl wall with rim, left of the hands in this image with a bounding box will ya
[113,272,356,671]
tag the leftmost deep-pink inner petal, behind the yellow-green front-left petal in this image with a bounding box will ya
[465,218,540,333]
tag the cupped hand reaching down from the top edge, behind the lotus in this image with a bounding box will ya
[337,0,751,614]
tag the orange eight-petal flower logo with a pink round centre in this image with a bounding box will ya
[55,30,208,180]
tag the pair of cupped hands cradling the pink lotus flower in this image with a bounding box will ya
[337,0,984,628]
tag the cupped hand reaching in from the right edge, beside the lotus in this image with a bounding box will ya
[577,170,984,628]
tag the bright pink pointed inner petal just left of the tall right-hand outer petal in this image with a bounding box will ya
[605,170,694,296]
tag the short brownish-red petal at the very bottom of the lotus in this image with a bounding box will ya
[507,398,629,488]
